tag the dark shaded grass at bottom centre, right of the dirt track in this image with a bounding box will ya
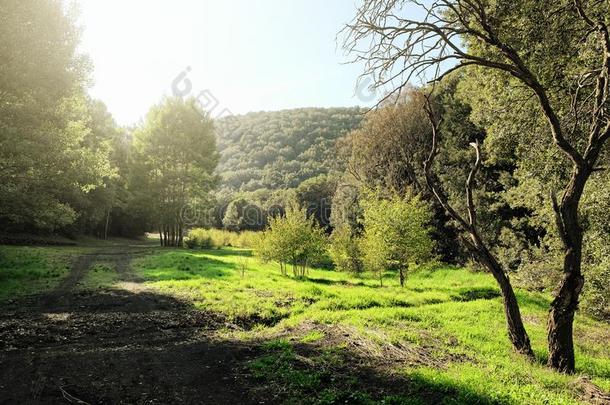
[248,327,508,404]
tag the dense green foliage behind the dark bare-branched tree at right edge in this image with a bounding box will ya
[448,1,609,316]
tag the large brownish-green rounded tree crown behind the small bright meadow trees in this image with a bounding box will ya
[338,89,466,263]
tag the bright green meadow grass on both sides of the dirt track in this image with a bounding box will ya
[0,241,610,404]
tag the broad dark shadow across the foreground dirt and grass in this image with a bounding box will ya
[0,312,497,404]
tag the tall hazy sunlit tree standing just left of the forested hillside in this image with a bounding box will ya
[135,98,218,246]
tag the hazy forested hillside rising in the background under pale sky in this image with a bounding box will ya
[216,107,364,191]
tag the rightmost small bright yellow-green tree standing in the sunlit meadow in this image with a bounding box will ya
[361,192,434,286]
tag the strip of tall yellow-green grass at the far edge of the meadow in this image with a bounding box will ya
[185,228,260,249]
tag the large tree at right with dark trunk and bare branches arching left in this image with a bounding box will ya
[348,0,610,372]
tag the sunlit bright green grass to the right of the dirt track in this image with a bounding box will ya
[134,249,610,404]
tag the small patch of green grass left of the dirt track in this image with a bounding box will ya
[0,246,78,300]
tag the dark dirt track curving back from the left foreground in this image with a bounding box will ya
[0,247,254,404]
